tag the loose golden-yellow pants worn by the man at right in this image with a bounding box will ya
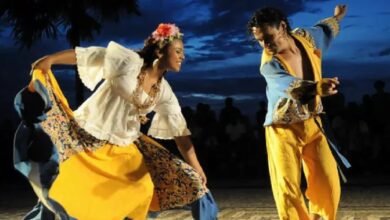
[265,118,340,220]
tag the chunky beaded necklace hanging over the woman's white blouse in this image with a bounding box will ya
[132,70,162,124]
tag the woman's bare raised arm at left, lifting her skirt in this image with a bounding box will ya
[32,49,77,73]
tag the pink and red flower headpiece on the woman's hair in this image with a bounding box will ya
[151,23,183,48]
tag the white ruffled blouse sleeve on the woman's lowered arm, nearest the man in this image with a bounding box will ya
[148,79,191,139]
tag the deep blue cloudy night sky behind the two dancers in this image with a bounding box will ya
[0,0,390,118]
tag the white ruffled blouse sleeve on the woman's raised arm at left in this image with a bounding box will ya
[75,46,106,90]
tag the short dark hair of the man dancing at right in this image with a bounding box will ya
[247,7,291,34]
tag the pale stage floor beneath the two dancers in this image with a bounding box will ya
[0,185,390,220]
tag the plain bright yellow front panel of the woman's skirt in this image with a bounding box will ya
[49,144,153,220]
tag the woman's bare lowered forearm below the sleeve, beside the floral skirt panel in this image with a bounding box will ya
[175,136,207,187]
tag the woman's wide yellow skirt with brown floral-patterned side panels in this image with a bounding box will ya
[19,70,208,219]
